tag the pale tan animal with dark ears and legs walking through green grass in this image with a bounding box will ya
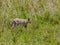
[11,18,31,28]
